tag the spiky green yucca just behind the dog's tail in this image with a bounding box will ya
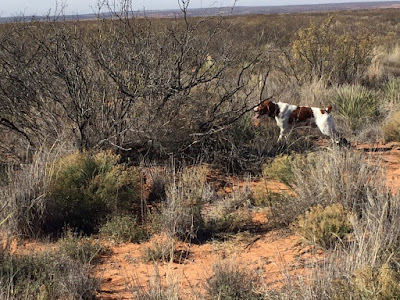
[333,85,379,132]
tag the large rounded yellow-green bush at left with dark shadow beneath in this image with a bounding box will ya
[45,151,140,233]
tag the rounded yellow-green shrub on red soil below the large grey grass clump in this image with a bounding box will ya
[293,204,353,249]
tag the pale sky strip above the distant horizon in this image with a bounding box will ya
[0,0,394,17]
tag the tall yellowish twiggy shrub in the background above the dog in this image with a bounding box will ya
[281,17,374,85]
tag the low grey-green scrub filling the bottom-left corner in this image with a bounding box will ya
[0,253,99,300]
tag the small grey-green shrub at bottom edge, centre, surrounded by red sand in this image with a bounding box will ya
[206,261,263,300]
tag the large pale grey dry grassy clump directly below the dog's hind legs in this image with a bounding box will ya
[291,148,385,216]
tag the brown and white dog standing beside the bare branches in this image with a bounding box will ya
[254,100,348,145]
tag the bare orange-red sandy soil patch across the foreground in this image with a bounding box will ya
[96,231,323,299]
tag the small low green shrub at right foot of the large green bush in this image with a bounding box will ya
[99,215,147,243]
